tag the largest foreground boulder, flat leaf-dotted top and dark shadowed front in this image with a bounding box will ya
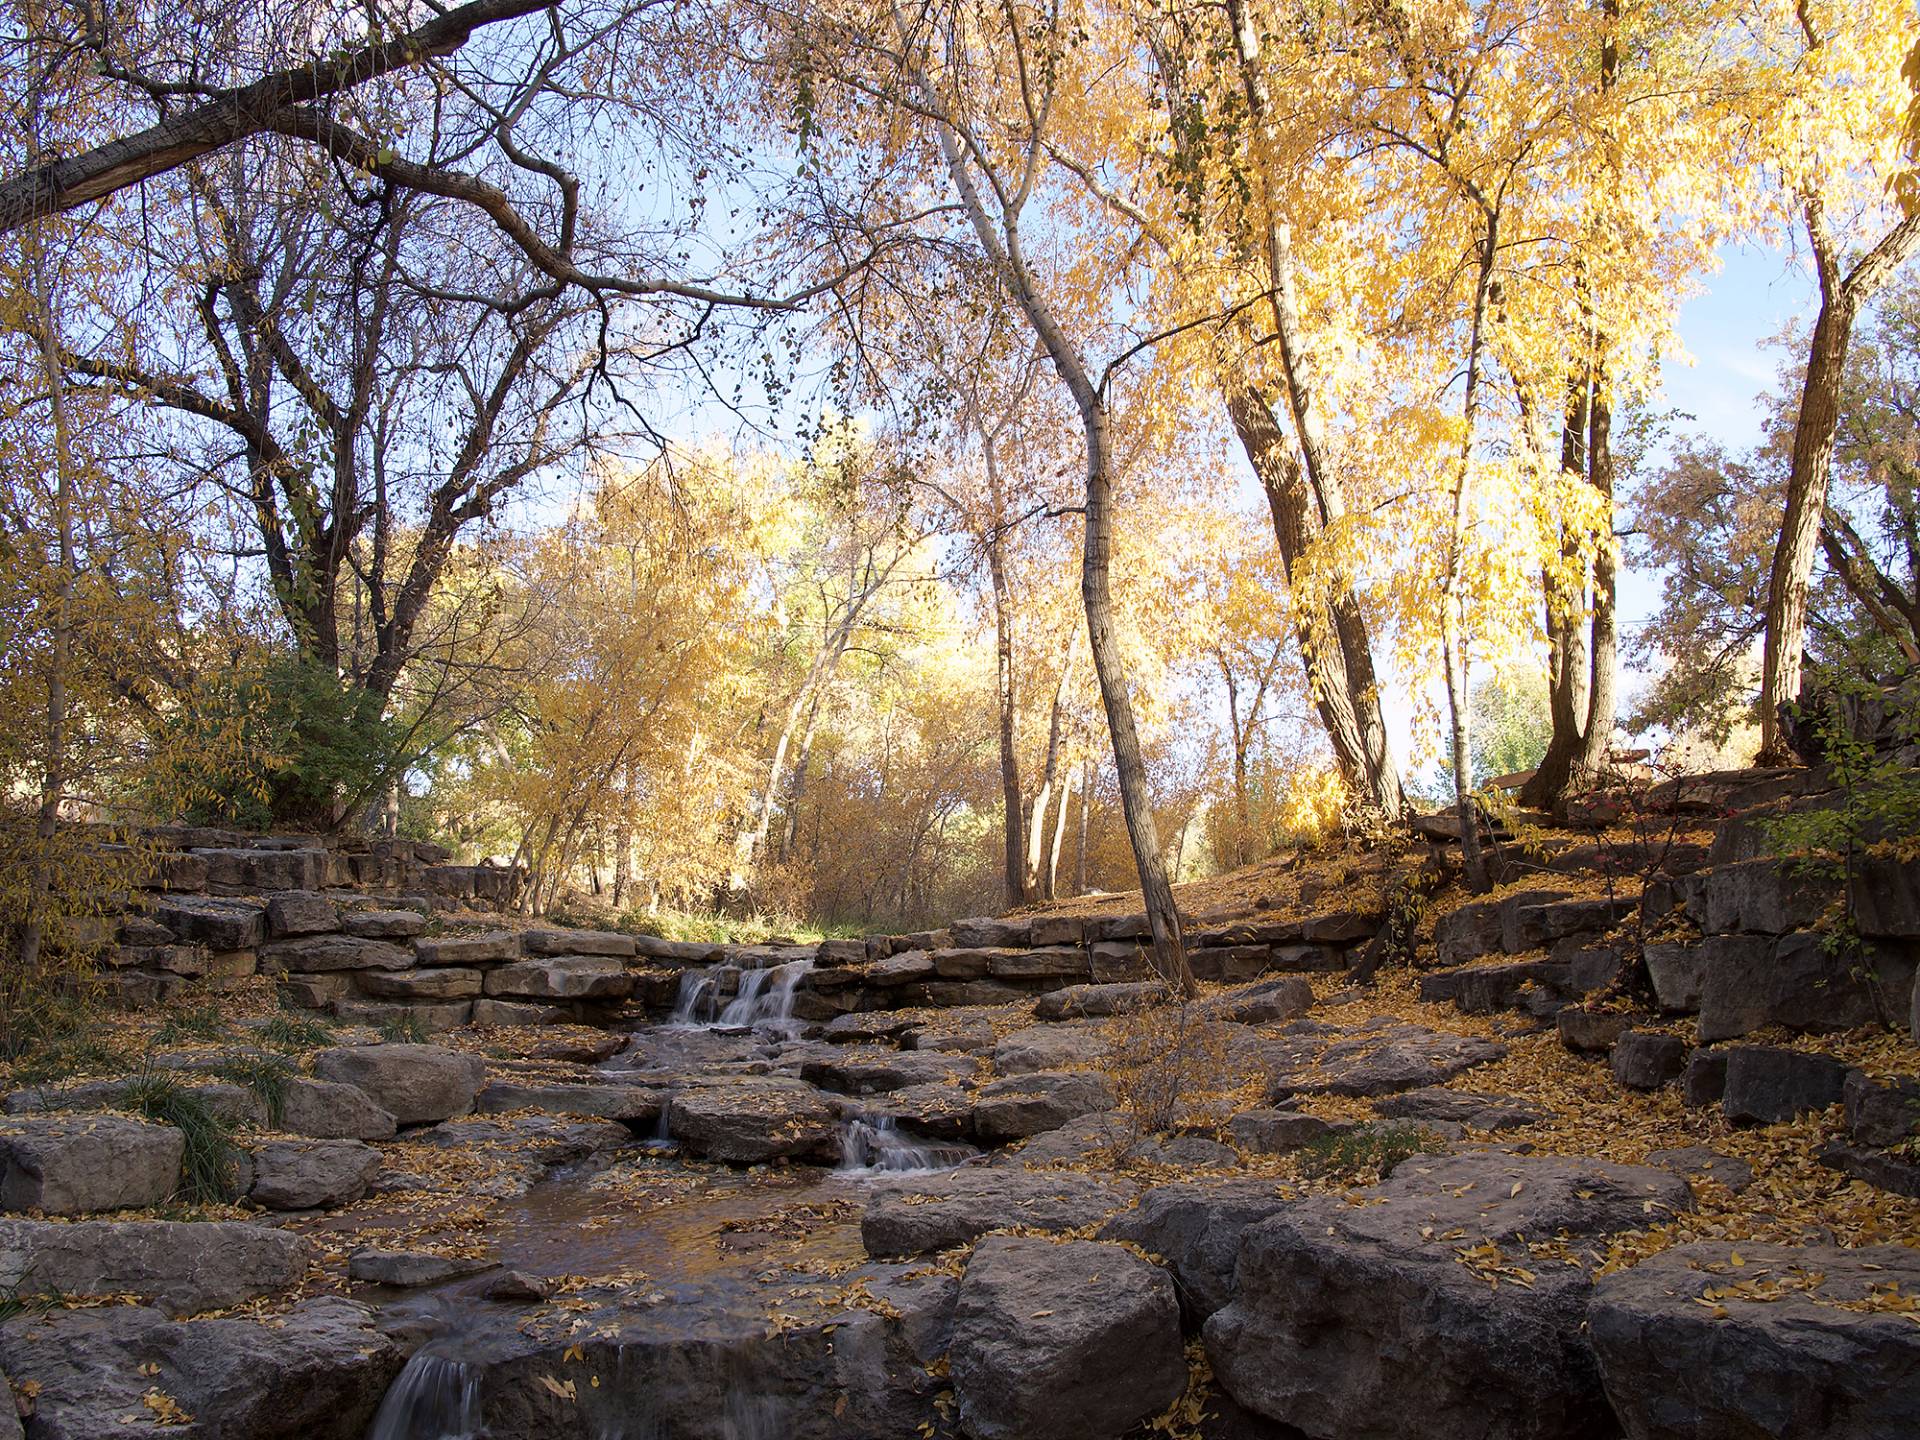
[1206,1152,1688,1440]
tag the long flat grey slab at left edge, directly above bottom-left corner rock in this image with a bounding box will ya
[0,1219,311,1313]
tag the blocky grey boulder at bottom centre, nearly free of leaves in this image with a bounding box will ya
[948,1236,1187,1440]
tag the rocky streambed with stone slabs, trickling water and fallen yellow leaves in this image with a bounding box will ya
[0,875,1920,1440]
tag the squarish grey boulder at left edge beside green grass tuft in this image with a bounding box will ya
[0,1116,186,1215]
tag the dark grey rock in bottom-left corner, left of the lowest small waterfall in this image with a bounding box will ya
[0,1296,401,1440]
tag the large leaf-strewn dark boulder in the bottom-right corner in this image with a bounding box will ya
[1590,1244,1920,1440]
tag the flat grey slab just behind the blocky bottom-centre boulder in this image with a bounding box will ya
[860,1165,1135,1260]
